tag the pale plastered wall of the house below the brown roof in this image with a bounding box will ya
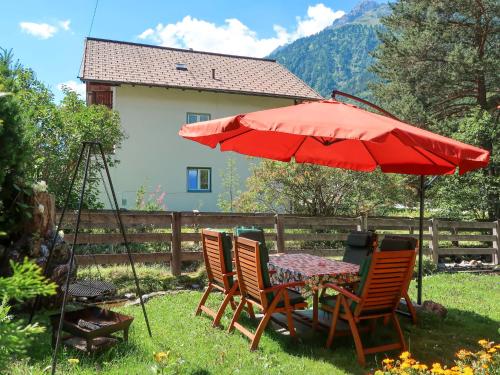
[109,85,294,211]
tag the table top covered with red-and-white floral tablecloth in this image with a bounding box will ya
[269,254,359,277]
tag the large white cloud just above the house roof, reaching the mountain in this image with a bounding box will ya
[137,3,345,57]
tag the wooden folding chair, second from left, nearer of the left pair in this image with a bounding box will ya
[228,237,307,350]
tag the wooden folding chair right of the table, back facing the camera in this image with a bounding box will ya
[322,250,416,366]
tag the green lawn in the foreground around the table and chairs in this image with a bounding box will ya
[10,273,500,375]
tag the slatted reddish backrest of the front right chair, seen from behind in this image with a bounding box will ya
[354,250,416,316]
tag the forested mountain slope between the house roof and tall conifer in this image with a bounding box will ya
[269,1,390,98]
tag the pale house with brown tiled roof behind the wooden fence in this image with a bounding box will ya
[80,38,321,211]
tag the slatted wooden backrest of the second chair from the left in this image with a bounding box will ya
[234,237,264,304]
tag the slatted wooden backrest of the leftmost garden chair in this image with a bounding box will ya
[201,229,227,286]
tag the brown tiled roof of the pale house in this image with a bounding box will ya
[80,38,322,100]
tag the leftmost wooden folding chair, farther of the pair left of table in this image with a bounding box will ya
[195,229,255,327]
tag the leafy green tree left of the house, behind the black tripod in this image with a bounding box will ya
[3,52,125,212]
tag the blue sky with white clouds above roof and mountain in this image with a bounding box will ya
[0,0,358,100]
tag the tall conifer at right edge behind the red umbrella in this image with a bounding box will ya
[371,0,500,220]
